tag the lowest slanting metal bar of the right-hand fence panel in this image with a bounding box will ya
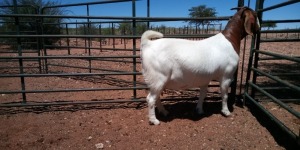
[245,93,299,144]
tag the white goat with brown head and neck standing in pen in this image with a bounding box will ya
[141,7,259,125]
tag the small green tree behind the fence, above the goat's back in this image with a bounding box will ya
[188,5,217,32]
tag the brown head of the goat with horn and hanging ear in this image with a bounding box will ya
[231,7,260,36]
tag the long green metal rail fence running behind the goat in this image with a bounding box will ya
[0,0,236,107]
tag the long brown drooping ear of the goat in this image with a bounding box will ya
[244,11,256,36]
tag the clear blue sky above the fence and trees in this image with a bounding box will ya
[53,0,300,29]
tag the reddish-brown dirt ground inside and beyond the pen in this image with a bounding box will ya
[0,34,300,150]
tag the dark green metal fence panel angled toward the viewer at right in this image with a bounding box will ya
[244,0,300,145]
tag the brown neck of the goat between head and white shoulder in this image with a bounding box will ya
[222,18,247,54]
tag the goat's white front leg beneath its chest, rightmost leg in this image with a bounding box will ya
[220,79,231,117]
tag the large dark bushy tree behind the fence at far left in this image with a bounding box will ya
[0,0,67,48]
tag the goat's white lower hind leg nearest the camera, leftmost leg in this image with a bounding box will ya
[147,92,159,125]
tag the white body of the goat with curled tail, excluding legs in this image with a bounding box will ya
[141,30,239,92]
